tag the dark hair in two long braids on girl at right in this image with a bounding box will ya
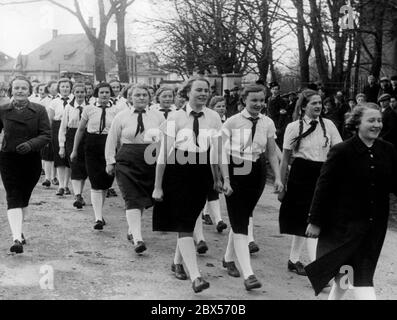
[292,89,329,151]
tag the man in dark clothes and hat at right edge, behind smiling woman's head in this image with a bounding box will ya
[378,93,397,148]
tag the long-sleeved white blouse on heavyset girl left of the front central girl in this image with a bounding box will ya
[105,107,164,164]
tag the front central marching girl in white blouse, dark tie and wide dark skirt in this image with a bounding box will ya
[153,78,226,292]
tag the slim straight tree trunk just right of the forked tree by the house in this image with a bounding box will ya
[116,4,130,83]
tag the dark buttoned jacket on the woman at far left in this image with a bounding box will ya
[0,102,51,152]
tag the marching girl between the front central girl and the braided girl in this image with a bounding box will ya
[222,85,283,290]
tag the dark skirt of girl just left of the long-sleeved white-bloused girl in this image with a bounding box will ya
[85,133,114,190]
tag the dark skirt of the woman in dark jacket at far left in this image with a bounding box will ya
[0,152,41,209]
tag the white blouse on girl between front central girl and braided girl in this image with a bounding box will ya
[222,109,276,161]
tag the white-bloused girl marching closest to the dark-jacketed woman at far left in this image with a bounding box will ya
[49,78,73,196]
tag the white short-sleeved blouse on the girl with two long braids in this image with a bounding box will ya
[283,116,342,162]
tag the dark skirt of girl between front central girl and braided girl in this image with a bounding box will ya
[225,154,266,235]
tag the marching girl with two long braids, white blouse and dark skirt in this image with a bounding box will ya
[279,89,342,276]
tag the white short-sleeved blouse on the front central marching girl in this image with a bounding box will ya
[160,104,222,152]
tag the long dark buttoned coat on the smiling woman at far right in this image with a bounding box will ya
[306,135,397,294]
